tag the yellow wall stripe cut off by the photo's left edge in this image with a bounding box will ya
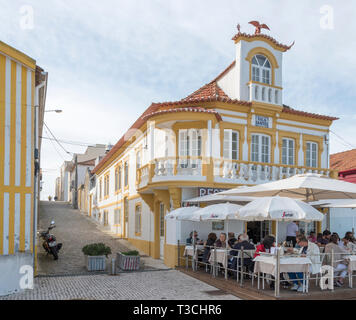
[0,55,6,255]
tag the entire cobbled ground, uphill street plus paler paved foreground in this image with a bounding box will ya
[0,202,239,300]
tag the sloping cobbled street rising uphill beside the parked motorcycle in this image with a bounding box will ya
[38,202,167,275]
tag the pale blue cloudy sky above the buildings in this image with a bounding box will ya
[0,0,356,199]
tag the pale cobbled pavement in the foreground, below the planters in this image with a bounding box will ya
[0,270,238,300]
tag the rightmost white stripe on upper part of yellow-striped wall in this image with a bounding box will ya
[26,70,34,187]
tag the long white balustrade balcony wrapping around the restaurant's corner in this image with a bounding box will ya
[136,157,337,189]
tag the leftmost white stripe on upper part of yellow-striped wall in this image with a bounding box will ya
[4,58,11,186]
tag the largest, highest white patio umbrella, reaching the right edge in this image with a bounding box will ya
[218,173,356,201]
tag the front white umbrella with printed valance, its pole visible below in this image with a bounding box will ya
[239,196,324,239]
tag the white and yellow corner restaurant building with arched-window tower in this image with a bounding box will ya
[89,28,337,266]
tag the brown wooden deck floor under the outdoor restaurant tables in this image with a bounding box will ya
[177,267,356,300]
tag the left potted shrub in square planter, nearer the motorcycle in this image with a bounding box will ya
[82,243,111,271]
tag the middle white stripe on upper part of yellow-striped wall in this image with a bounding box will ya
[15,63,22,186]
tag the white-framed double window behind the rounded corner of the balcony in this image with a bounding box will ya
[179,129,202,168]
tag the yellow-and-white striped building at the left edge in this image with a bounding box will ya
[0,41,47,295]
